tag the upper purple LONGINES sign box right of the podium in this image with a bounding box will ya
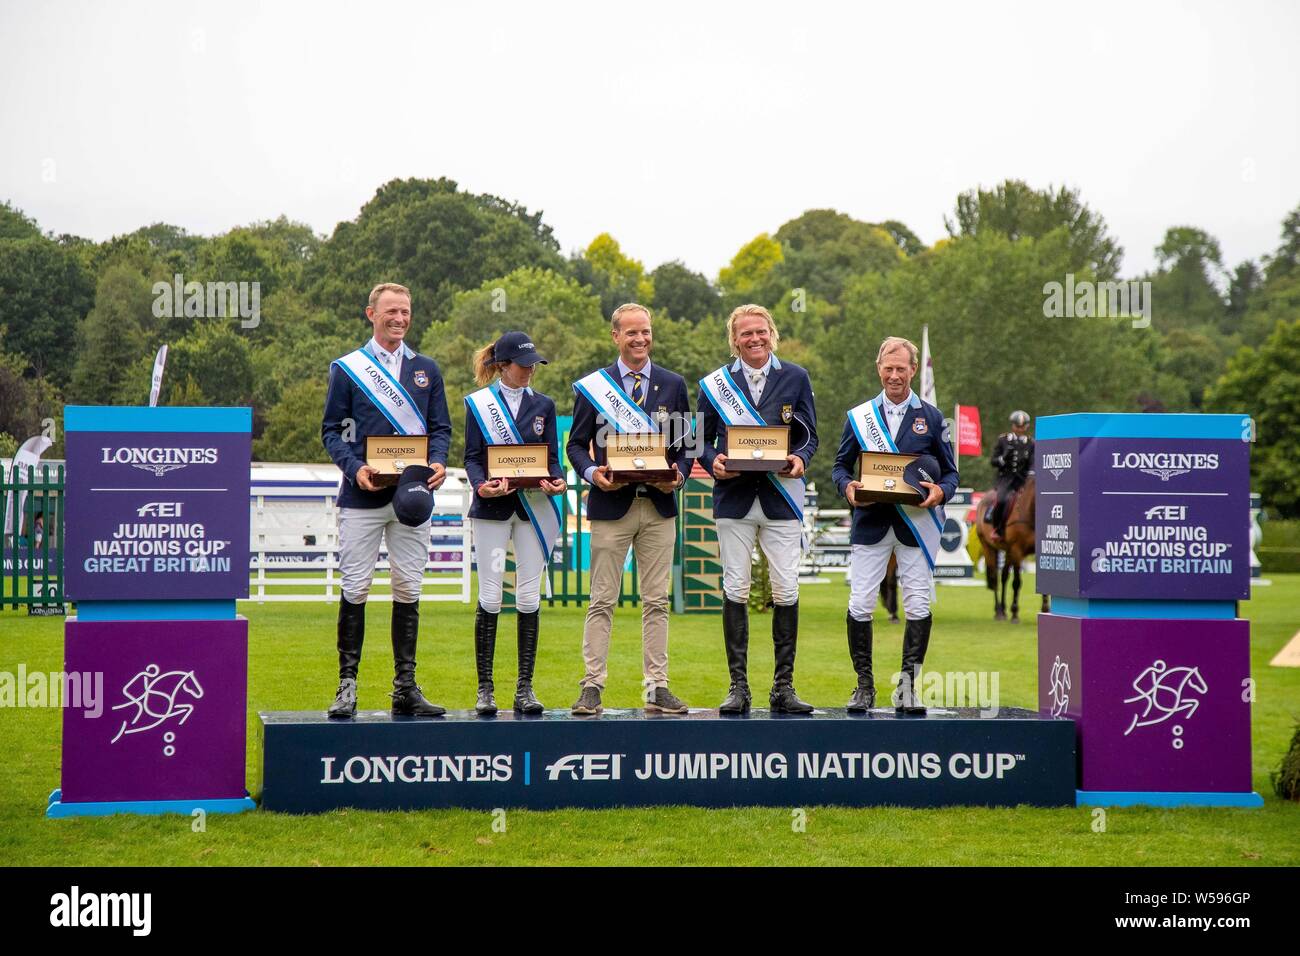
[1035,438,1251,601]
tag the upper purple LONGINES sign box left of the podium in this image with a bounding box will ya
[64,431,251,601]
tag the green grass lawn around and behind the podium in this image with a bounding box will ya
[0,575,1300,866]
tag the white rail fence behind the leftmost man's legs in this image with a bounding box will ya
[248,466,472,604]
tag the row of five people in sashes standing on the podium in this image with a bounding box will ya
[321,282,958,719]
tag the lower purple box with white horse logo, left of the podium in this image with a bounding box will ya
[62,616,248,804]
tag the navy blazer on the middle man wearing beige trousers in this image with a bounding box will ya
[566,360,690,522]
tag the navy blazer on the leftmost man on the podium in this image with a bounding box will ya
[321,343,451,507]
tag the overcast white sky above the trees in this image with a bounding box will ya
[0,0,1300,278]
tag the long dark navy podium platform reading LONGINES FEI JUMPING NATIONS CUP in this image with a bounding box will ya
[257,708,1076,813]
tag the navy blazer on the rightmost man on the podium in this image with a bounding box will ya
[831,392,958,548]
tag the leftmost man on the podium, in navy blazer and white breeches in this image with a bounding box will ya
[321,282,451,718]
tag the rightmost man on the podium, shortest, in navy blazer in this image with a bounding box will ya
[831,336,958,714]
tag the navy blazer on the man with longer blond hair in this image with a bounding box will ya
[699,355,818,520]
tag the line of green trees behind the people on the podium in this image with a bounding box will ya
[0,178,1300,515]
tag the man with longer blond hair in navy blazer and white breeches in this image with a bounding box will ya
[699,304,818,714]
